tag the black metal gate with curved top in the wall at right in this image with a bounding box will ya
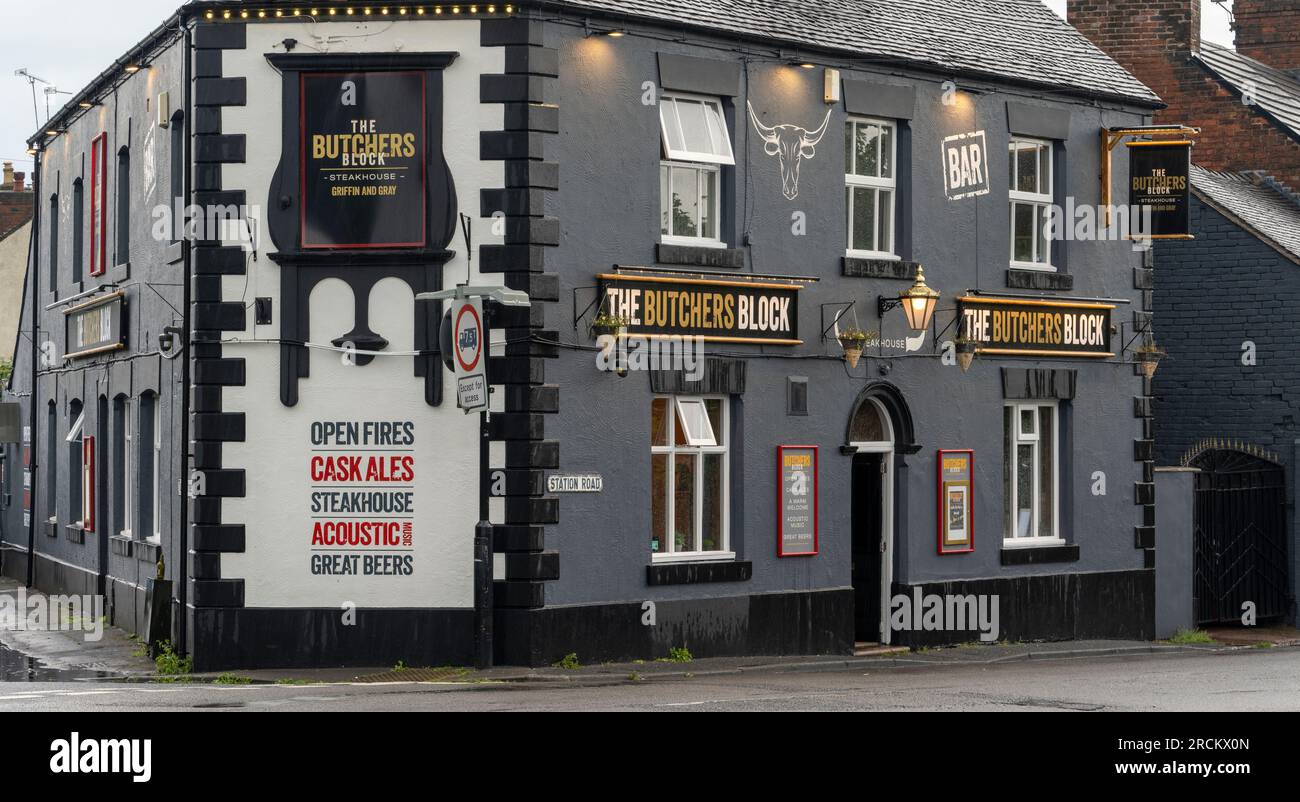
[1190,448,1290,625]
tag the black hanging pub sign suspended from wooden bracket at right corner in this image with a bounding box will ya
[1128,140,1192,239]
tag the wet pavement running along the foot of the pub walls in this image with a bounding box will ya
[0,571,1300,688]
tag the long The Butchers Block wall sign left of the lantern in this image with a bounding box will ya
[597,274,802,346]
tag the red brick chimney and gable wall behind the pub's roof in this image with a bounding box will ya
[1067,0,1300,190]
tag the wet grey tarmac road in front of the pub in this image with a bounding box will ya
[0,649,1300,712]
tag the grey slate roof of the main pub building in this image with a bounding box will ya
[538,0,1160,105]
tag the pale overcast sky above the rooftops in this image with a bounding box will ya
[0,0,1232,173]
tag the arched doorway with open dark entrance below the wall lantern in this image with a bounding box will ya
[845,382,917,645]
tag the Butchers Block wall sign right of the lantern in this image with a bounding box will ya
[958,296,1115,357]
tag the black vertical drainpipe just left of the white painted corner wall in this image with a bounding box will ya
[173,17,195,656]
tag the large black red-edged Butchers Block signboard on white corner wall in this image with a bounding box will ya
[300,71,428,248]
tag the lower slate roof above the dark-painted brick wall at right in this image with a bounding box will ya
[1192,165,1300,261]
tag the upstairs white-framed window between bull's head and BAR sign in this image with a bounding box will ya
[844,120,898,257]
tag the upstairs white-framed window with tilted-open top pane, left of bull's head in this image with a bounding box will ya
[659,95,736,247]
